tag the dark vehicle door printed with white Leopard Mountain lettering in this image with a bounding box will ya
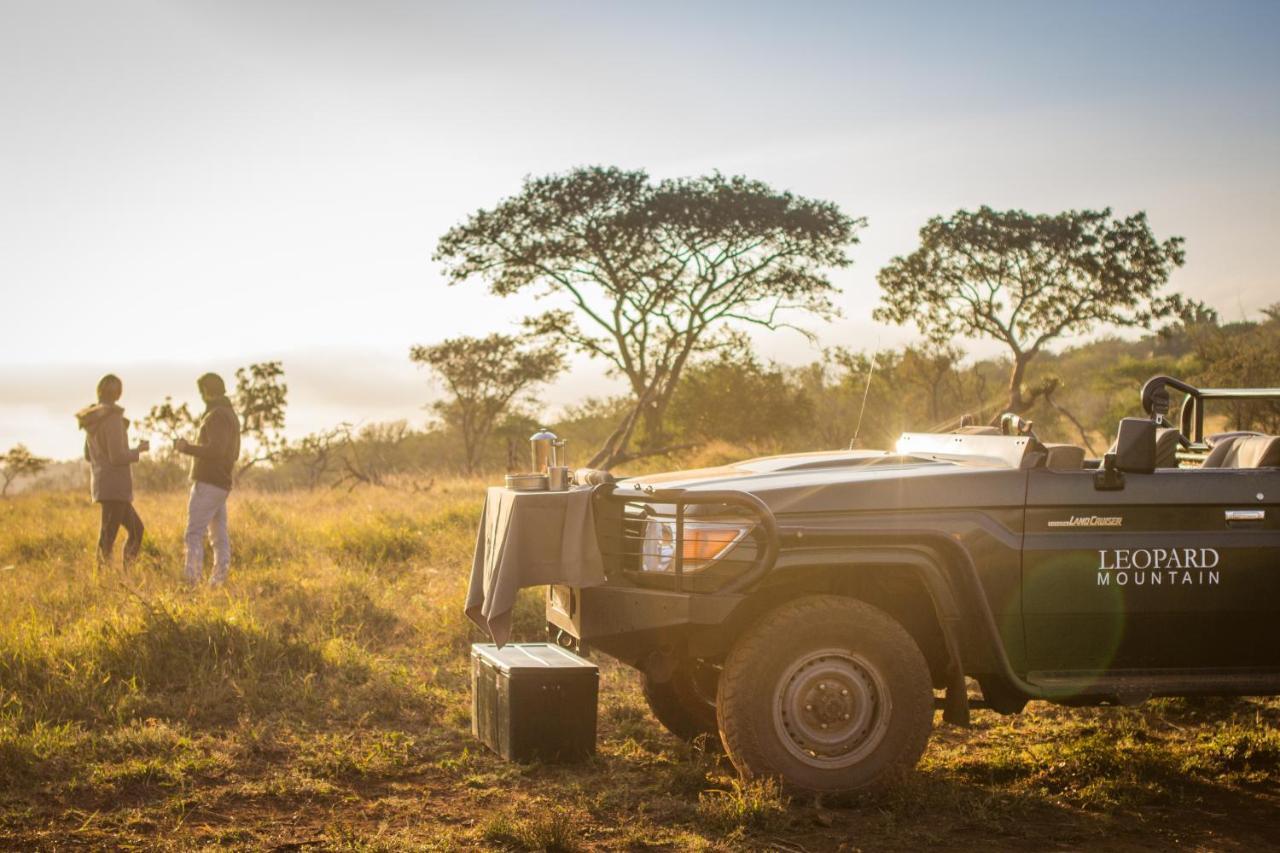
[1023,469,1280,672]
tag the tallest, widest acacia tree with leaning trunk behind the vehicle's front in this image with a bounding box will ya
[435,167,865,467]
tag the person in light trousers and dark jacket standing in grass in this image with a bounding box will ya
[174,373,241,587]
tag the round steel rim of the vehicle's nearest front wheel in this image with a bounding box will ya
[773,648,892,770]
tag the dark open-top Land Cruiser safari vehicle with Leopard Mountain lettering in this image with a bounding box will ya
[547,377,1280,792]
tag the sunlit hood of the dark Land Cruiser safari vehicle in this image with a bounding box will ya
[618,450,1027,514]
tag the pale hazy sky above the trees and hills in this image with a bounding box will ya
[0,0,1280,457]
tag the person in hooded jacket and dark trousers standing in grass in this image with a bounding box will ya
[76,374,151,567]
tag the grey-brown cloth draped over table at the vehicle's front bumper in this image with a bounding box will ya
[466,485,604,646]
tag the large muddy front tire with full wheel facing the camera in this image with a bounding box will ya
[717,596,933,792]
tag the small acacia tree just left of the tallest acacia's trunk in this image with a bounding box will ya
[410,334,564,474]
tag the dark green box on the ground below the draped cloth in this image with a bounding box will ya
[471,643,600,763]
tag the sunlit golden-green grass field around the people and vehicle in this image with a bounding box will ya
[0,482,1280,850]
